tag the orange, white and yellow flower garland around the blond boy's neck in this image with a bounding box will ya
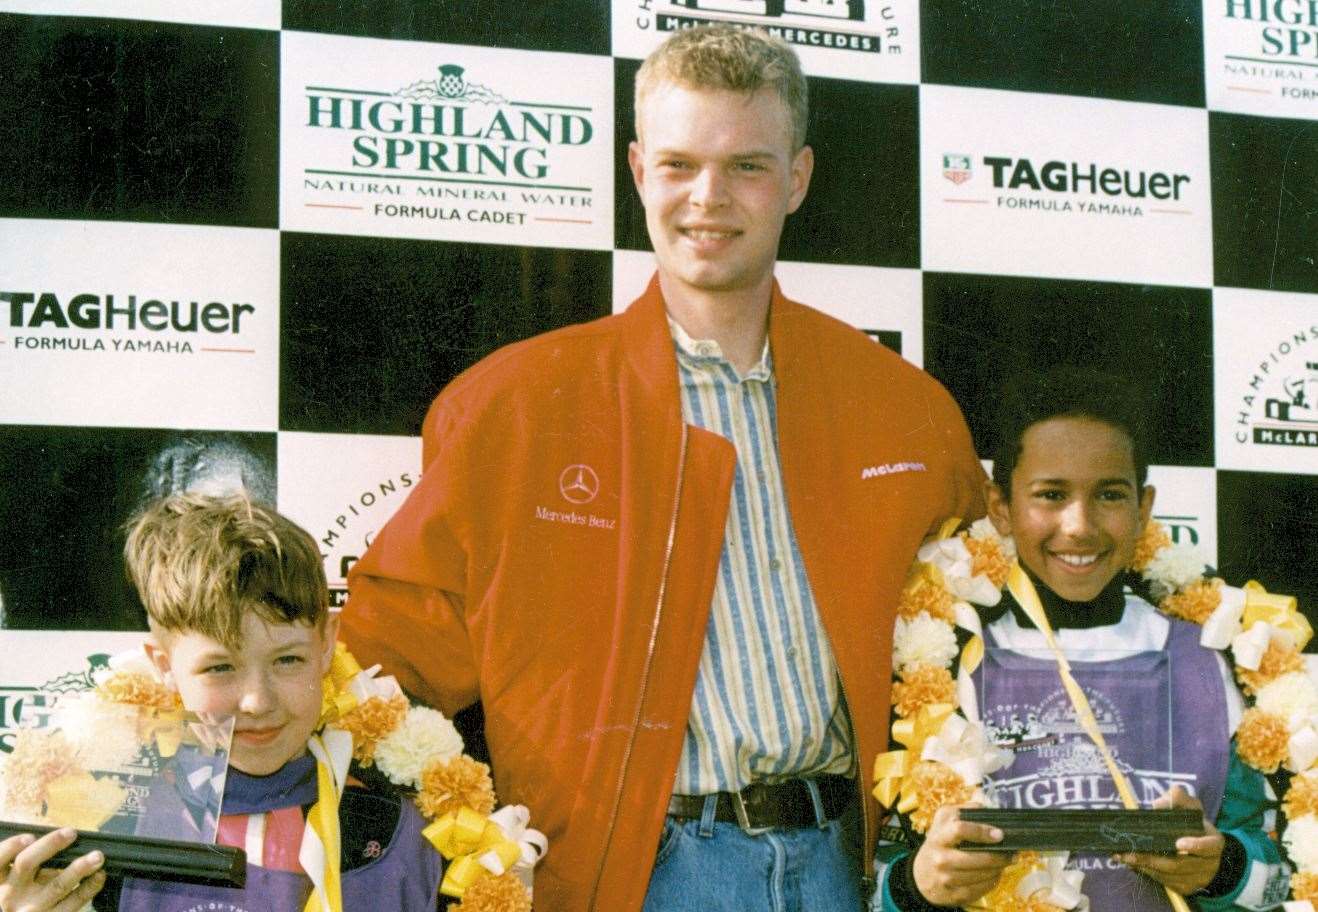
[96,643,548,912]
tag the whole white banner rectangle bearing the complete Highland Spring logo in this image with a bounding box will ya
[279,32,613,249]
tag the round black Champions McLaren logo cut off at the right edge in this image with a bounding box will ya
[1232,324,1318,447]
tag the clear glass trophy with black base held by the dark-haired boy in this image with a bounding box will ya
[962,648,1203,853]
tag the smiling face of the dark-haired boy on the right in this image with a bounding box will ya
[989,418,1153,601]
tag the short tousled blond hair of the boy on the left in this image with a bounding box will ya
[124,493,330,650]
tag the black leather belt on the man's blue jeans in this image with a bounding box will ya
[668,775,858,833]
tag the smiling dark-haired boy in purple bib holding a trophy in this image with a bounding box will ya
[875,368,1286,912]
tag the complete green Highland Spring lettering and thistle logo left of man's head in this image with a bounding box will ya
[302,63,597,227]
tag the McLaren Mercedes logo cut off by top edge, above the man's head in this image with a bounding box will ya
[634,0,902,54]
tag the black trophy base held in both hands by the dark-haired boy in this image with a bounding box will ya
[957,808,1203,855]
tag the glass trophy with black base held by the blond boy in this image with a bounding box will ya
[0,691,246,886]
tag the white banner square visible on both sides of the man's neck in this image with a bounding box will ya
[613,250,924,366]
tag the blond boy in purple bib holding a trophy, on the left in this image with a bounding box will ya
[0,494,440,912]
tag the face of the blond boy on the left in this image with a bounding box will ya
[148,613,339,776]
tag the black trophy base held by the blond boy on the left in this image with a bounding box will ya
[0,820,246,887]
